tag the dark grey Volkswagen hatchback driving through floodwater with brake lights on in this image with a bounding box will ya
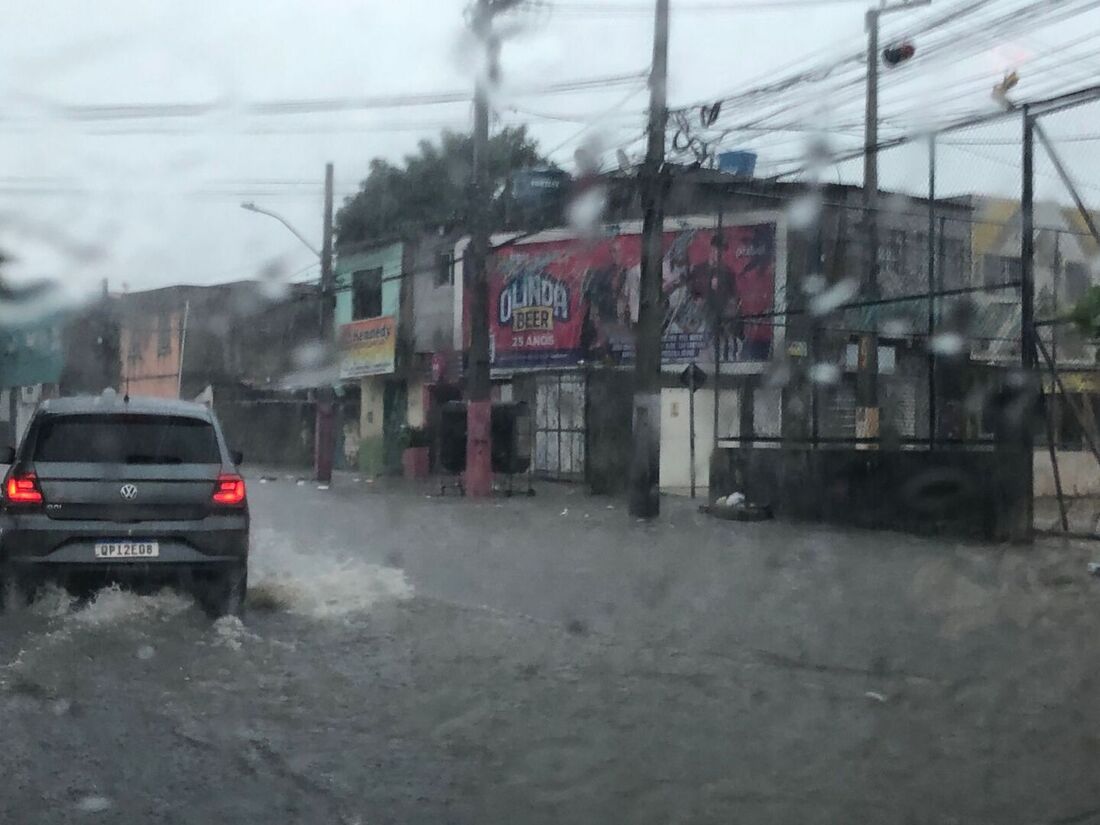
[0,391,249,615]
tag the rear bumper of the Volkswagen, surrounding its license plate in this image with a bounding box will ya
[0,513,249,570]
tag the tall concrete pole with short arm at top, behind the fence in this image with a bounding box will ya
[856,0,932,438]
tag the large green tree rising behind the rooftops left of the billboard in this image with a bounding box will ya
[336,127,547,245]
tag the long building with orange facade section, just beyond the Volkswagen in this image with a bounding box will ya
[114,281,322,466]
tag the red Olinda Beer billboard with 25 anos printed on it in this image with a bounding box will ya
[465,220,779,370]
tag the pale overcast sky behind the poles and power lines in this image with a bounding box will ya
[0,0,1100,297]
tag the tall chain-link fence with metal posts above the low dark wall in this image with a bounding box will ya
[686,94,1100,543]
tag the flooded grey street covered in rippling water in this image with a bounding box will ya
[0,477,1100,825]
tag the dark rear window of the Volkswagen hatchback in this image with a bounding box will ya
[34,415,221,464]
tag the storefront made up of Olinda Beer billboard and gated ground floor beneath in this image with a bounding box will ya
[455,212,787,490]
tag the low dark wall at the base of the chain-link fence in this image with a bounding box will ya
[711,448,1032,541]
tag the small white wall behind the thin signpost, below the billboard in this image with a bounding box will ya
[660,388,741,495]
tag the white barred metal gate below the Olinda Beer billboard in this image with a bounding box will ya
[535,373,587,481]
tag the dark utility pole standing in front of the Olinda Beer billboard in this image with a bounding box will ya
[630,0,669,518]
